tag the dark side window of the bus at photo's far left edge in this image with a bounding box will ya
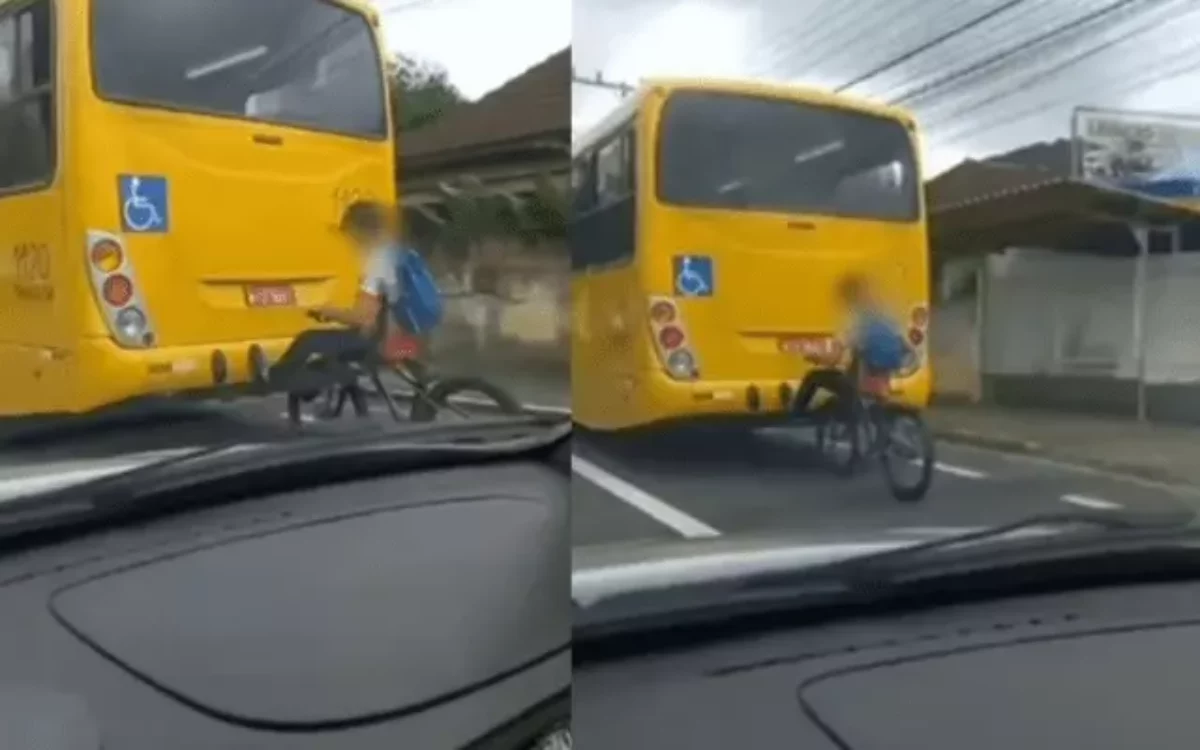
[0,0,55,191]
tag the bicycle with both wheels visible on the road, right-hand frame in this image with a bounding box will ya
[815,348,935,503]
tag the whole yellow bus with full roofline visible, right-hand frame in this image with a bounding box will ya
[571,79,930,431]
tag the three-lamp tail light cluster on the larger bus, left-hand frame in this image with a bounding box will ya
[88,230,155,349]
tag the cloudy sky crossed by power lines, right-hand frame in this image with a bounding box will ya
[573,0,1200,172]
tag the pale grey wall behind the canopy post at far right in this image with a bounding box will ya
[980,250,1200,422]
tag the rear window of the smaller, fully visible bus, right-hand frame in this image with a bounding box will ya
[658,91,920,222]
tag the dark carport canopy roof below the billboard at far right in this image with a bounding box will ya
[929,178,1200,259]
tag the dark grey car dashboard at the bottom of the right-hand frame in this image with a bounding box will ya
[572,583,1200,750]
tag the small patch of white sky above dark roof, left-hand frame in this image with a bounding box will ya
[374,0,571,98]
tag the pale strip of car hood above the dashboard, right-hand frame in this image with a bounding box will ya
[571,526,1032,607]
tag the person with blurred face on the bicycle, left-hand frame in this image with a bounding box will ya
[268,202,415,383]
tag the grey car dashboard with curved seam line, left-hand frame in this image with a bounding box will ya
[0,460,571,750]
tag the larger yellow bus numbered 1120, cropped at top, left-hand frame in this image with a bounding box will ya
[0,0,396,416]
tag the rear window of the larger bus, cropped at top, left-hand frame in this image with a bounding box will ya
[91,0,388,138]
